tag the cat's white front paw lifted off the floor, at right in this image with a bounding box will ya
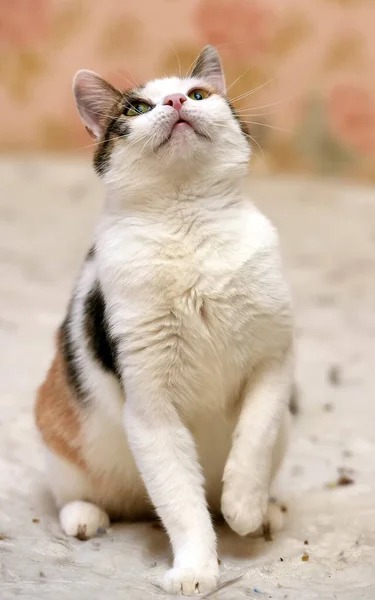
[221,480,268,536]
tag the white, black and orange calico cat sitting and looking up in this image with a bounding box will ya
[36,46,293,595]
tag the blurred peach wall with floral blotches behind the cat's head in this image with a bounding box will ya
[0,0,375,180]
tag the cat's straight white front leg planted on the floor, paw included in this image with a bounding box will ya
[124,391,219,595]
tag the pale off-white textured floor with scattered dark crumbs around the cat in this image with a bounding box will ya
[0,159,375,600]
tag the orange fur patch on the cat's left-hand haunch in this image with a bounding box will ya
[35,331,86,470]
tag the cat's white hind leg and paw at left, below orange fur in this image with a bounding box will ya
[47,450,109,539]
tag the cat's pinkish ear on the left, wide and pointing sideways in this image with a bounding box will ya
[73,70,121,139]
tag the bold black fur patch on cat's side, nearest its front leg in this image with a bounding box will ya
[84,282,120,379]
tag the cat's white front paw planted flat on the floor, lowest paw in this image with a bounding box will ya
[161,567,219,596]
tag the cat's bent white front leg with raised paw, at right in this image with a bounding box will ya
[221,354,292,535]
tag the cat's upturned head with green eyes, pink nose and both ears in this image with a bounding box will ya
[73,46,250,189]
